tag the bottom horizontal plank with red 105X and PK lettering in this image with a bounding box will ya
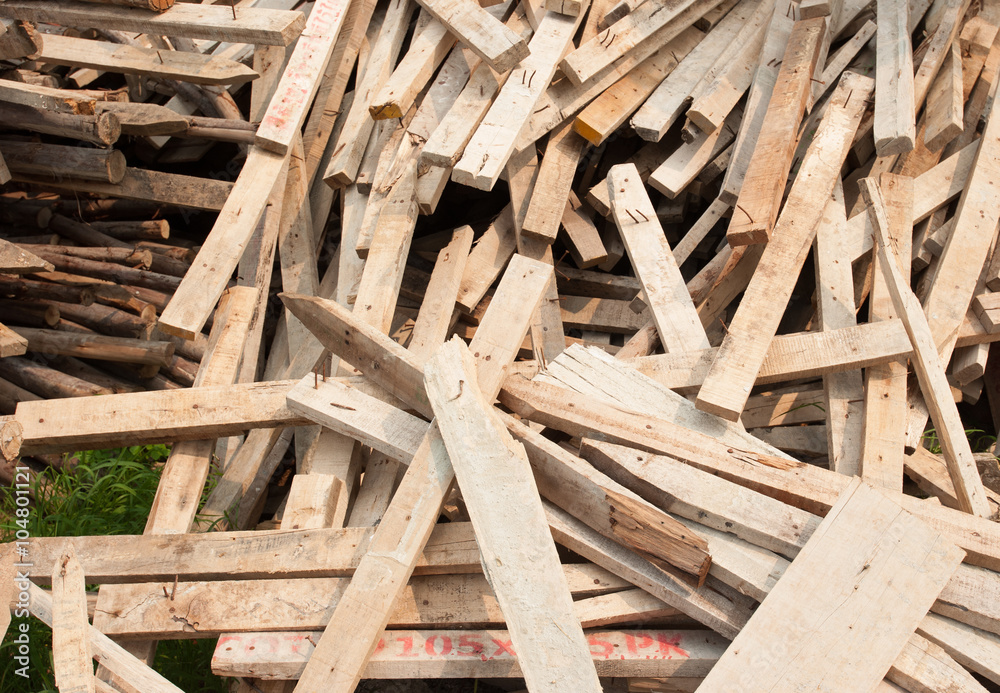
[212,630,725,679]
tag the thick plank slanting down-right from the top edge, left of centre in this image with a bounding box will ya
[420,0,528,72]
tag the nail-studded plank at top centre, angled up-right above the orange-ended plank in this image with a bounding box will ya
[559,0,721,84]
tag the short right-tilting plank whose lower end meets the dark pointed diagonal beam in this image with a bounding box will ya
[408,226,473,358]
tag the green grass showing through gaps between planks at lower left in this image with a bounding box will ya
[0,445,228,693]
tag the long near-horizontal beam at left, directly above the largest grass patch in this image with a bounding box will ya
[15,381,308,454]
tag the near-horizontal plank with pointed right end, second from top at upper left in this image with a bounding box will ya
[39,34,260,84]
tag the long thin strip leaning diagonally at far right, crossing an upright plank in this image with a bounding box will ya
[860,178,990,517]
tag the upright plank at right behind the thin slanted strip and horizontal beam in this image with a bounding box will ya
[860,173,913,491]
